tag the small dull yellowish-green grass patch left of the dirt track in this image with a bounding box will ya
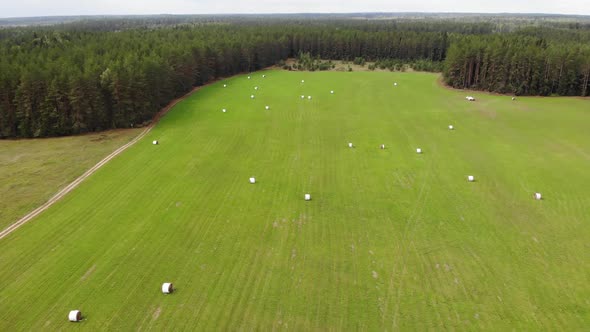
[0,129,140,230]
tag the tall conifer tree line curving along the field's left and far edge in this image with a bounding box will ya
[0,24,446,137]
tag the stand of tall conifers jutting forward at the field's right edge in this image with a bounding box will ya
[444,35,590,96]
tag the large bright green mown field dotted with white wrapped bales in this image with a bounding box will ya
[0,71,590,331]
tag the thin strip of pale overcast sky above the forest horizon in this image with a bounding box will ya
[0,0,590,17]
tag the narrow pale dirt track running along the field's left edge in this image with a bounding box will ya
[0,87,202,240]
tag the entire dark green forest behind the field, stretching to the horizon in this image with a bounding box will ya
[0,14,590,138]
